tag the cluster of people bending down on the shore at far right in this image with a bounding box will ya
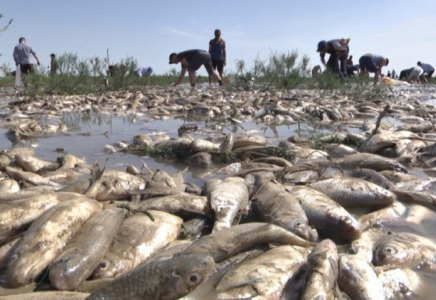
[312,38,434,83]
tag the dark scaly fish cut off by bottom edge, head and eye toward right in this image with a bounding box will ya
[86,255,214,300]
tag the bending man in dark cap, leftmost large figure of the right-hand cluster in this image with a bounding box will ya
[316,39,350,80]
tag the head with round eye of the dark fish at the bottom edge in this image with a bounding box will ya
[171,254,215,293]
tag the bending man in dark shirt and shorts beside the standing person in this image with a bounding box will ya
[170,49,223,87]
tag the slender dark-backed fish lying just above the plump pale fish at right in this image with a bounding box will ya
[334,153,407,173]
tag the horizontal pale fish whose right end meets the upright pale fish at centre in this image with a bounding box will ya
[129,193,213,218]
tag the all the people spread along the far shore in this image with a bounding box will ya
[13,34,435,87]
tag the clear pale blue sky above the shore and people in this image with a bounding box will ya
[0,0,436,74]
